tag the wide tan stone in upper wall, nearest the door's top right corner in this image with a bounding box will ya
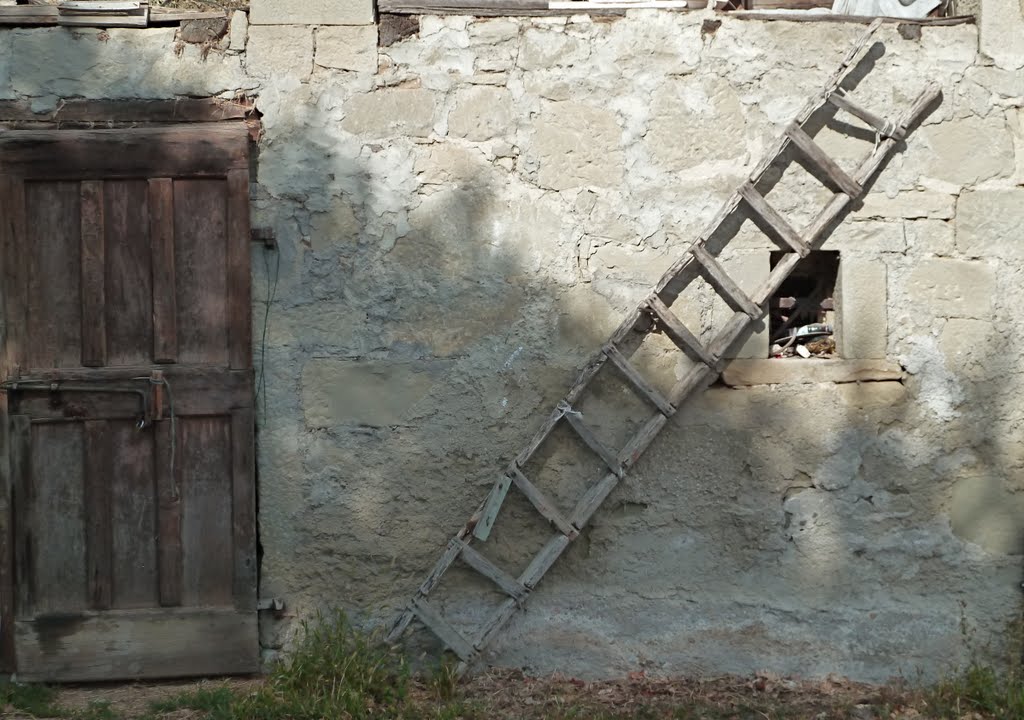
[341,88,435,137]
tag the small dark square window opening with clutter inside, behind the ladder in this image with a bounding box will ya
[768,250,839,358]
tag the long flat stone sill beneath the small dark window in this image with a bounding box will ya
[722,357,905,387]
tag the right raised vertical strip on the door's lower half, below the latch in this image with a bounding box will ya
[155,420,181,606]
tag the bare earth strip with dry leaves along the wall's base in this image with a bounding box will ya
[0,671,970,720]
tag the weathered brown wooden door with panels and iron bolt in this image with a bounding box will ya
[0,123,258,680]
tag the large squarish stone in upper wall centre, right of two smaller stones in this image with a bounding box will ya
[527,102,624,190]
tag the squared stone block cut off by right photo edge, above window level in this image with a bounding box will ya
[956,187,1024,258]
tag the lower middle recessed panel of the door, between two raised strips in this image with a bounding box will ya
[108,421,160,608]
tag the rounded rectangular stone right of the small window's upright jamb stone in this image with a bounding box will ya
[905,257,995,320]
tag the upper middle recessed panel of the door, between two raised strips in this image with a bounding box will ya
[104,180,153,365]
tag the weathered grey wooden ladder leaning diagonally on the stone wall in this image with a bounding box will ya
[388,20,941,672]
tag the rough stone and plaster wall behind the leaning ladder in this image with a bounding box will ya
[0,0,1024,680]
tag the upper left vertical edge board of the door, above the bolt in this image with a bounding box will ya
[0,175,29,378]
